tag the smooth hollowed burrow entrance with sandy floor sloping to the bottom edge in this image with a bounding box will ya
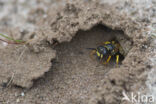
[32,25,132,104]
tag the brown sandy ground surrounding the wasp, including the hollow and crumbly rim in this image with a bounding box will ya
[0,0,155,104]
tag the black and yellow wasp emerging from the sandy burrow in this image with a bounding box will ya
[87,41,123,65]
